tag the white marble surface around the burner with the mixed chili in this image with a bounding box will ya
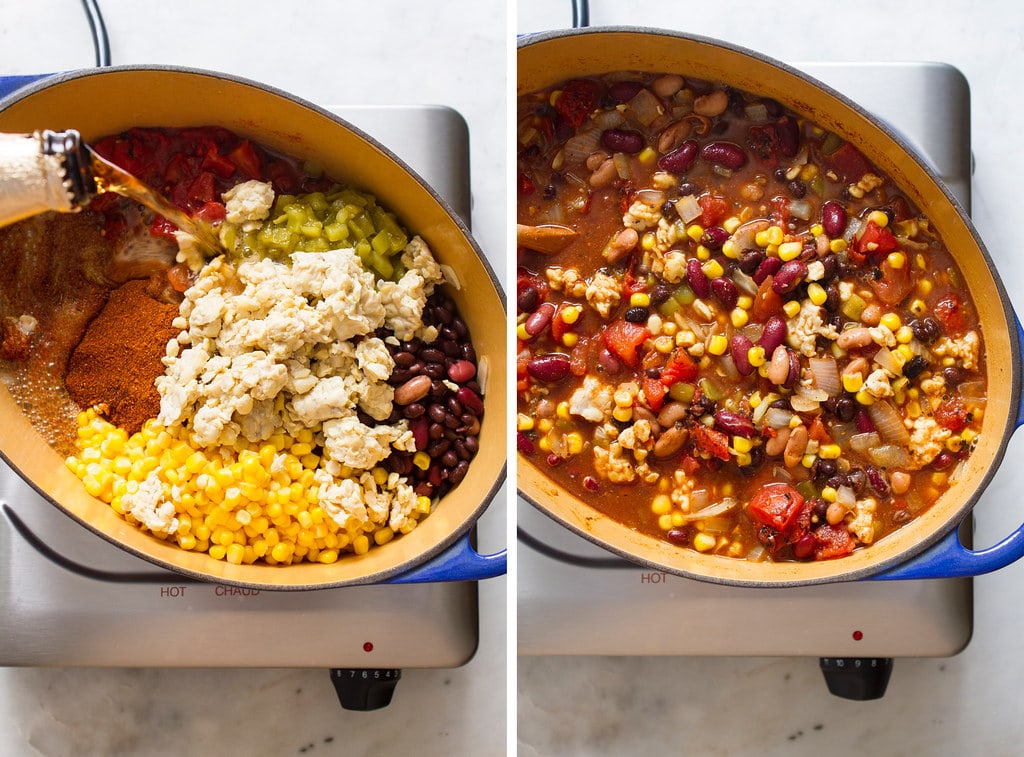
[516,0,1024,757]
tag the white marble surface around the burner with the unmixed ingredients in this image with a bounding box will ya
[0,0,509,757]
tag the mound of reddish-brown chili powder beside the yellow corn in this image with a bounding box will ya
[65,280,178,433]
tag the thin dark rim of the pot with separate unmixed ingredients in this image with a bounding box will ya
[0,64,508,591]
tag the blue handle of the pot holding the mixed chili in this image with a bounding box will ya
[871,312,1024,581]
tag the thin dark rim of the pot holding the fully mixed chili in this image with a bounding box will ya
[517,26,1021,588]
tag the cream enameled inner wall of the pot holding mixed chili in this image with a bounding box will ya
[518,29,1020,586]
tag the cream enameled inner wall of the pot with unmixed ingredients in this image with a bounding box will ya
[0,67,507,589]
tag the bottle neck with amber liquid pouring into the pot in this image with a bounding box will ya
[0,129,223,252]
